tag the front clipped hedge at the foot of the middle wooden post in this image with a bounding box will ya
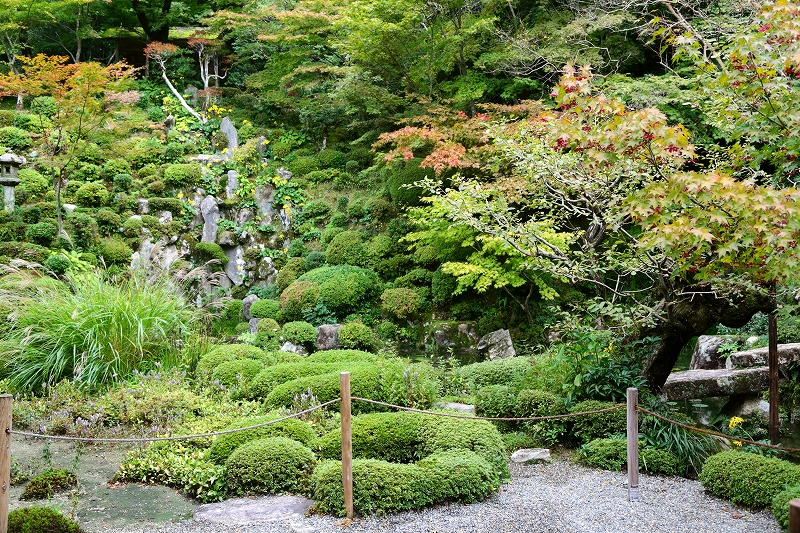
[311,459,436,516]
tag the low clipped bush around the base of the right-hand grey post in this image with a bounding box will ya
[578,439,683,476]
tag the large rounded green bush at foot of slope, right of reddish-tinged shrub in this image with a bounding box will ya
[298,265,381,318]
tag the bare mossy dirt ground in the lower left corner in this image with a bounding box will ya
[9,435,199,532]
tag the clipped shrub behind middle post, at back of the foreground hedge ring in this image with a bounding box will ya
[314,412,428,463]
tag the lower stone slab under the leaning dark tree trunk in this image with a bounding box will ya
[660,366,769,401]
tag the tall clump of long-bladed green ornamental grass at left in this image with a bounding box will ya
[0,274,193,391]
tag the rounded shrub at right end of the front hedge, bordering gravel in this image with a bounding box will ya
[417,450,500,503]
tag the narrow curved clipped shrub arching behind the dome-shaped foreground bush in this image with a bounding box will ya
[208,414,318,465]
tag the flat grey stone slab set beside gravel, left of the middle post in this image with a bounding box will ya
[194,496,314,524]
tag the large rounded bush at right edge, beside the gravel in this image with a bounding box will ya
[699,450,800,508]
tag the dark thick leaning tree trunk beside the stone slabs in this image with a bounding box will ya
[642,289,775,392]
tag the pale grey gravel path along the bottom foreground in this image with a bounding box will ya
[96,461,780,533]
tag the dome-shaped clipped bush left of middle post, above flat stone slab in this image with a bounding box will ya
[225,437,316,494]
